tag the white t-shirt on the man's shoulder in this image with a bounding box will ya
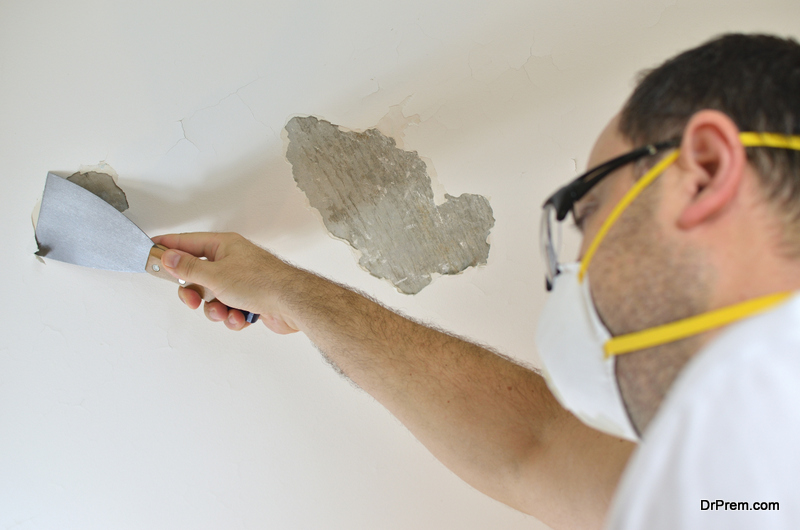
[607,290,800,530]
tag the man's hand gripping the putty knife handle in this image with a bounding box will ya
[153,232,301,334]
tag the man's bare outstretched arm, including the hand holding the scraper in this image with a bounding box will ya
[157,234,633,528]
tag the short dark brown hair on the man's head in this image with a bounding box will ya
[619,34,800,245]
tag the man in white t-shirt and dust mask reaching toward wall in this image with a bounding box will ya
[156,35,800,529]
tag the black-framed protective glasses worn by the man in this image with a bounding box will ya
[539,139,680,291]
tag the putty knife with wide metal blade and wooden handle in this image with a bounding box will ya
[36,173,258,323]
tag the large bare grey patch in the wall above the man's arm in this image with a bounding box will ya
[286,117,494,294]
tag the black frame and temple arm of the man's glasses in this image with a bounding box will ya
[542,138,681,221]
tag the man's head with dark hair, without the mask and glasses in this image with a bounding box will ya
[575,35,800,431]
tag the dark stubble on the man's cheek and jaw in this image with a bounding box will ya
[589,179,711,434]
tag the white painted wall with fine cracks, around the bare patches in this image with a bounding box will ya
[0,0,800,529]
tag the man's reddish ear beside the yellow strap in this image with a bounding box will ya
[676,110,747,229]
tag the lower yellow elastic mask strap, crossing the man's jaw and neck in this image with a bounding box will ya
[603,292,793,358]
